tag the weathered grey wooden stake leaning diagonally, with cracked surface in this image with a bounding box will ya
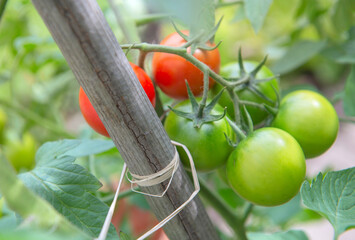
[32,0,219,240]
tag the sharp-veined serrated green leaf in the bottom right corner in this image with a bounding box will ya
[301,168,355,239]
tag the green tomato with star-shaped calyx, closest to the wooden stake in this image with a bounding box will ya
[164,101,234,171]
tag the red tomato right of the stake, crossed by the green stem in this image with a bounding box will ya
[152,31,220,99]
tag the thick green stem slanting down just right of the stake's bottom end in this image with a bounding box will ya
[199,179,247,240]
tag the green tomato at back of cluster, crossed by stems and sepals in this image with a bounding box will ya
[213,61,279,124]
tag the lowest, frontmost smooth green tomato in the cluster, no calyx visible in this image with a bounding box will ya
[227,128,306,206]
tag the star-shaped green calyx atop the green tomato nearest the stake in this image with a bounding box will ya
[169,81,227,128]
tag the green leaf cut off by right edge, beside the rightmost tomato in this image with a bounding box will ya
[343,65,355,116]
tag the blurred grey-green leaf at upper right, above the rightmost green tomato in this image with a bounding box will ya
[271,41,326,74]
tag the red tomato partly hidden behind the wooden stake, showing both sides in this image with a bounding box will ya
[79,63,155,137]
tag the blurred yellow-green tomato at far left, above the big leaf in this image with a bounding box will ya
[5,133,36,172]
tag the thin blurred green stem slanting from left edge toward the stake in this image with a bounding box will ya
[0,99,75,138]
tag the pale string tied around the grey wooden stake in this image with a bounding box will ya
[95,141,200,240]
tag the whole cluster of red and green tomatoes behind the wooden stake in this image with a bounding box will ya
[79,31,339,206]
